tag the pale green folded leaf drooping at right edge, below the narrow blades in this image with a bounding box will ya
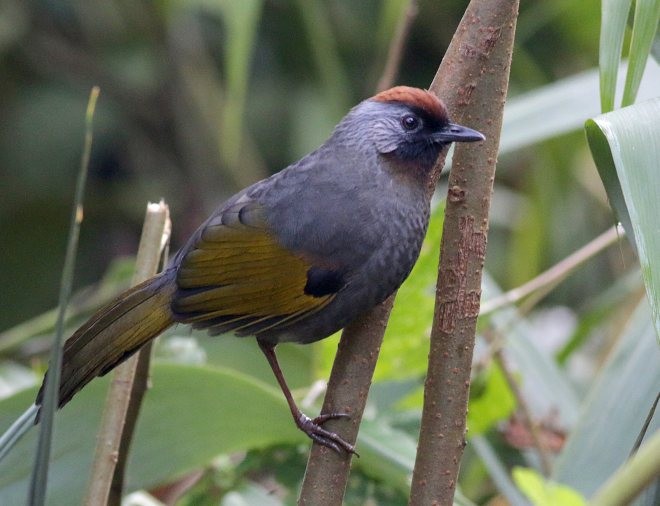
[586,98,660,336]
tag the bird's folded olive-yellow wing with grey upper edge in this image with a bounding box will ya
[172,197,335,334]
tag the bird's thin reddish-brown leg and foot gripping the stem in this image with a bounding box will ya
[257,340,356,453]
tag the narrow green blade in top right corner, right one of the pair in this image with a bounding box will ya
[621,0,660,107]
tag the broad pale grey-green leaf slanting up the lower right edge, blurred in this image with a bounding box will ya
[553,301,660,497]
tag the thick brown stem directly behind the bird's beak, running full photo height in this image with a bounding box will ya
[410,0,518,506]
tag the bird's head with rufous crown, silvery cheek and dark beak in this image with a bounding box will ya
[338,86,485,169]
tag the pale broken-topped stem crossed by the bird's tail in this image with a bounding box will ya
[84,202,169,506]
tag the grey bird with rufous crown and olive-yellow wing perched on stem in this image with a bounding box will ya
[35,86,485,453]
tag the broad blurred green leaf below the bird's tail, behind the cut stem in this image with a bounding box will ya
[0,364,307,505]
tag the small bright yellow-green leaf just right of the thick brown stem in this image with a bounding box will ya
[467,364,516,437]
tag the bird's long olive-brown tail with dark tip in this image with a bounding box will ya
[36,271,176,407]
